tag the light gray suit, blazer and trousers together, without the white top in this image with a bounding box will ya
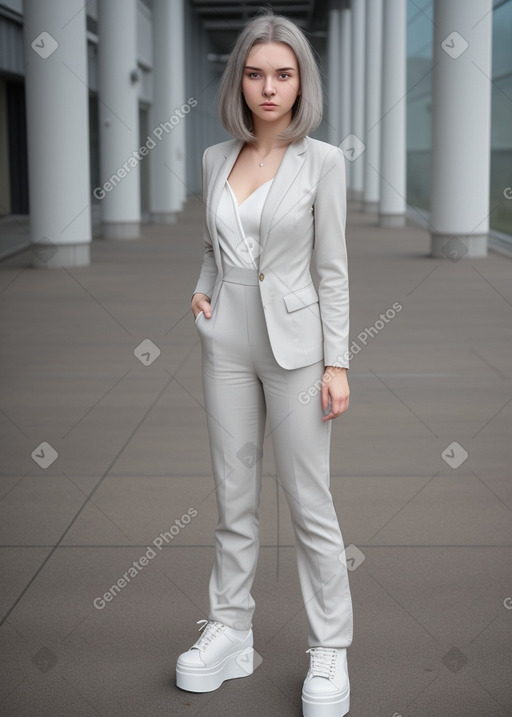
[194,138,352,648]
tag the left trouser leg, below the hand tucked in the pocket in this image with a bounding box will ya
[200,283,265,630]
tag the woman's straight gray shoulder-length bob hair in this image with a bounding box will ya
[218,10,323,143]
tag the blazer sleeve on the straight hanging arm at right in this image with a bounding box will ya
[313,147,349,368]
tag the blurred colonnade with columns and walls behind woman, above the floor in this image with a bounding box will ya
[0,0,512,267]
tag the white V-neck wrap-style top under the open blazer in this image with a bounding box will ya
[217,178,274,269]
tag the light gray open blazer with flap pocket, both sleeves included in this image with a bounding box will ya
[194,137,349,369]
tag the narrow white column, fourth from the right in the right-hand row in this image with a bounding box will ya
[350,0,366,200]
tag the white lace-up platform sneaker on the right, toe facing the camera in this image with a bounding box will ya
[302,647,350,717]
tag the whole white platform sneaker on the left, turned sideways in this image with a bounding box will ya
[176,620,254,692]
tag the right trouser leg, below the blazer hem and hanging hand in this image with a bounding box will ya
[264,362,353,648]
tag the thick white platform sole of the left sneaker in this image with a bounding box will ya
[176,647,254,692]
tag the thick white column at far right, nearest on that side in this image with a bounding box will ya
[430,0,493,260]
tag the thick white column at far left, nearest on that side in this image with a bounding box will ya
[23,0,91,268]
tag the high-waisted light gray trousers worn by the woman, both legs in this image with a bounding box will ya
[195,268,352,648]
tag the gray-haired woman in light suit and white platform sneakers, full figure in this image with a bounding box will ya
[176,11,352,717]
